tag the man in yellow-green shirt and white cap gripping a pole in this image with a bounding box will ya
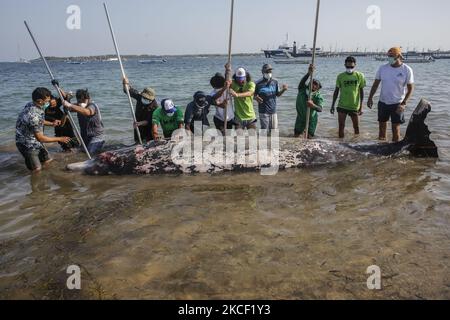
[230,68,257,129]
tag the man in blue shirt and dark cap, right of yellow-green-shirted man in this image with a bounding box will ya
[255,64,288,130]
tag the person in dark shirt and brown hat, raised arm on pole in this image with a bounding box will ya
[123,78,158,143]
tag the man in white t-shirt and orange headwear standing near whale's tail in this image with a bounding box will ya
[367,47,414,142]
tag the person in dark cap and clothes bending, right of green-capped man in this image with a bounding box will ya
[184,91,211,133]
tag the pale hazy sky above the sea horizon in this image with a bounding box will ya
[0,0,450,61]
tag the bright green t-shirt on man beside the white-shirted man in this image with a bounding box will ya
[336,71,366,111]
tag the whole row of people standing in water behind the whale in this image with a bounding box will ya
[16,48,414,172]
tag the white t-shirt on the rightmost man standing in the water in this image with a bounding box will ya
[376,64,414,104]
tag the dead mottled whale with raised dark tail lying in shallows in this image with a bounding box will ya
[67,99,438,175]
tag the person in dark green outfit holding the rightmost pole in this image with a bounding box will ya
[295,65,324,138]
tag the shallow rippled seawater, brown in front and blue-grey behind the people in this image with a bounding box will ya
[0,58,450,299]
